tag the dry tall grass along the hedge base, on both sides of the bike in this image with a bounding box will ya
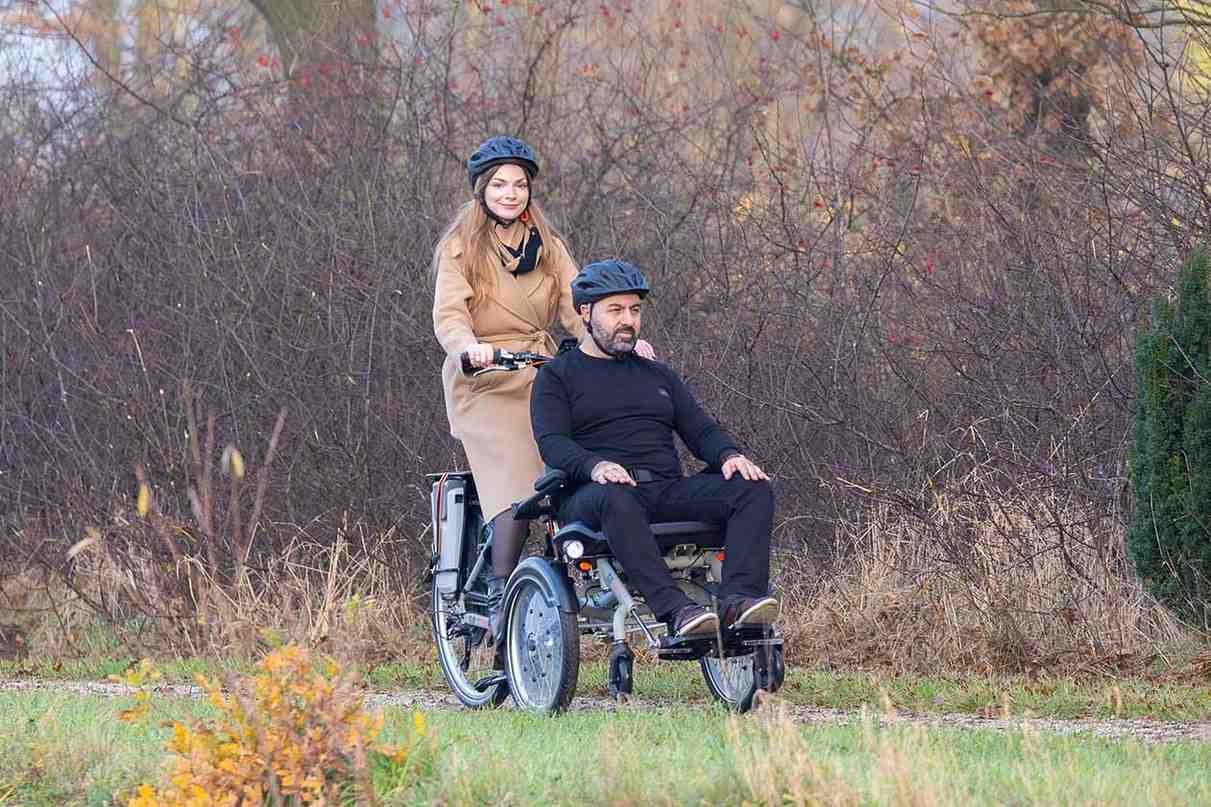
[0,458,1190,674]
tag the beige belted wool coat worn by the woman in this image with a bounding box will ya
[434,232,584,520]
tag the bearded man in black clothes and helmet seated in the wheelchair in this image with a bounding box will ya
[530,261,779,636]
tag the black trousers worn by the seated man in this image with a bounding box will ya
[561,474,774,620]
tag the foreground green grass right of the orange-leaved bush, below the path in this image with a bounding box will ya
[404,706,1211,803]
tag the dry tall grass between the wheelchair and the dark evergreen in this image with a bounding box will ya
[779,471,1188,673]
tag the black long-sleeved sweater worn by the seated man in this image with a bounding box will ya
[530,348,740,482]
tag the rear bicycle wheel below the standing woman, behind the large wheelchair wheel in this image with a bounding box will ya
[432,585,509,709]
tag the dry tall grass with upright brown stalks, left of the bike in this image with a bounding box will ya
[0,409,429,664]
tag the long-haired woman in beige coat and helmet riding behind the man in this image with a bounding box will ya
[434,136,652,635]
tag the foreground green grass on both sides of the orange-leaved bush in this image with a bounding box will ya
[0,691,1211,806]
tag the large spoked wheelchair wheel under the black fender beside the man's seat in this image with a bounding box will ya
[505,559,580,714]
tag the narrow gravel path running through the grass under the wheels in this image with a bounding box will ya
[0,681,1211,743]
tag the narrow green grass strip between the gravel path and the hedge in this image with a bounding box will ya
[7,658,1211,720]
